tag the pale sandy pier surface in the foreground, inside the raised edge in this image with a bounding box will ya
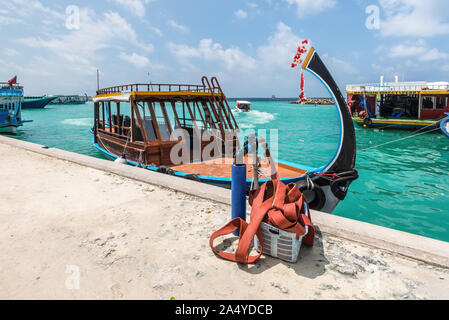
[0,143,449,299]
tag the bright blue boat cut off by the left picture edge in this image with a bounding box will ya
[0,81,30,133]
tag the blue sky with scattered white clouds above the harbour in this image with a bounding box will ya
[0,0,449,97]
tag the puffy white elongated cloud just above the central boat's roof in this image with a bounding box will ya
[168,39,256,70]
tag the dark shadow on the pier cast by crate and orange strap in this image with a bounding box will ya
[212,227,329,279]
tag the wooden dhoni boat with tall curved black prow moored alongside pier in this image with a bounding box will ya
[92,48,357,212]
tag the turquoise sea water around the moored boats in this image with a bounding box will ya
[10,101,449,241]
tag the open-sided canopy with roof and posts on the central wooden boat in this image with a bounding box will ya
[93,77,238,143]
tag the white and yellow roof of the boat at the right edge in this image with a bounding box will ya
[346,81,449,95]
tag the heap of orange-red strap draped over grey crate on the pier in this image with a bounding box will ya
[209,179,315,264]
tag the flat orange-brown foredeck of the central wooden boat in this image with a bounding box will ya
[171,157,307,179]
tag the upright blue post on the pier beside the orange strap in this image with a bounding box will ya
[231,164,246,237]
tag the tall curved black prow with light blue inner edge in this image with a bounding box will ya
[302,48,358,212]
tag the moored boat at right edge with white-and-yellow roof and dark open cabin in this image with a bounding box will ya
[346,76,449,131]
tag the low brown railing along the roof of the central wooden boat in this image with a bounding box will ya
[97,83,218,95]
